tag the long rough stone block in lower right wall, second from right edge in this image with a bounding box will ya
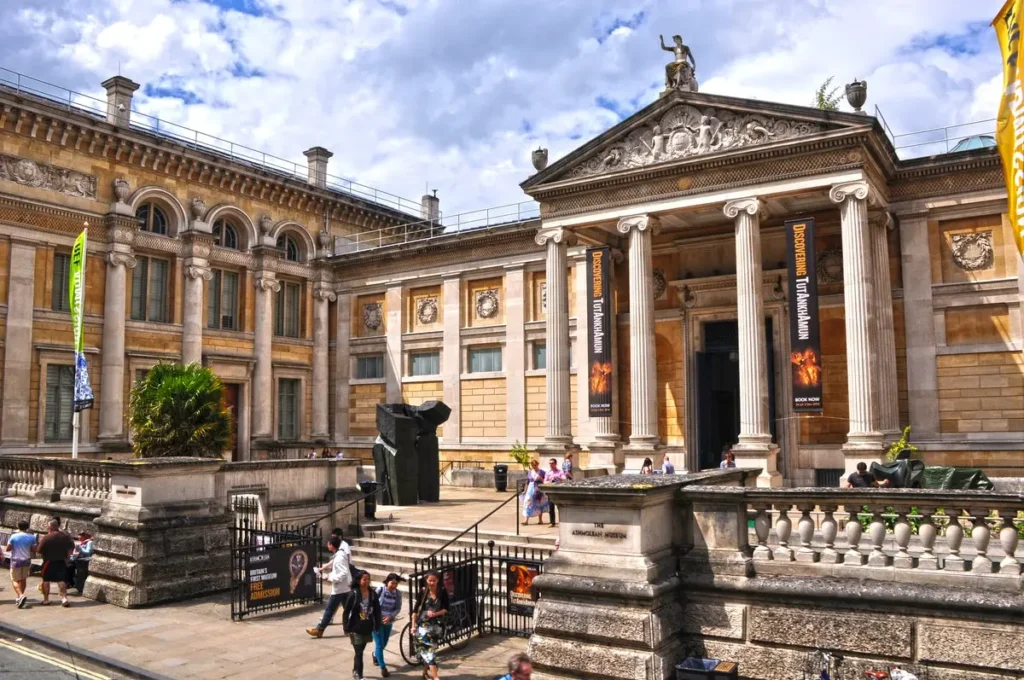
[750,606,913,658]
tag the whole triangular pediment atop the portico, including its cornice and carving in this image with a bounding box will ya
[523,93,873,189]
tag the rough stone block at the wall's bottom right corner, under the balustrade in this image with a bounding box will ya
[918,621,1024,672]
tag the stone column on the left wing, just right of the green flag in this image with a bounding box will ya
[97,215,135,441]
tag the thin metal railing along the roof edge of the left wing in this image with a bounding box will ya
[0,67,420,214]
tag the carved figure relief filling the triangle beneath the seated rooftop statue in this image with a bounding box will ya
[569,103,823,177]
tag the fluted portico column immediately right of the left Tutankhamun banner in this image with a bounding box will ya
[617,215,658,464]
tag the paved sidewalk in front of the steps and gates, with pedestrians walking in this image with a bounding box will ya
[0,578,526,680]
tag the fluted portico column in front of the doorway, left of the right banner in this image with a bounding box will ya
[724,199,781,486]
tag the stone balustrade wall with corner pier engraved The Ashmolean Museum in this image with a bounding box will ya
[529,470,1024,680]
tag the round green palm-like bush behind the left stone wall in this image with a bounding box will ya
[129,364,232,458]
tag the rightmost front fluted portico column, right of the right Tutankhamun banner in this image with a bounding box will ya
[828,181,882,472]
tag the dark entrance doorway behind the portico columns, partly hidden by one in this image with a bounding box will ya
[697,318,775,470]
